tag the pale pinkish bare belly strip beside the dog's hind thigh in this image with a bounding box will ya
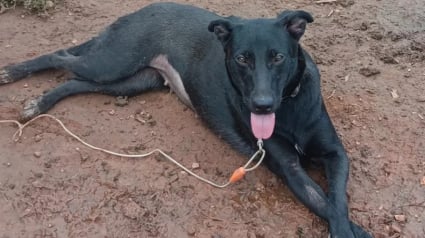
[149,54,193,109]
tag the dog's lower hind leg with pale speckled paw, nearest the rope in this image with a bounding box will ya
[21,68,165,121]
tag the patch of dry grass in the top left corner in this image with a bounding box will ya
[0,0,57,13]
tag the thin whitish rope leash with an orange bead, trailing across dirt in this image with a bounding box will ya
[0,114,266,188]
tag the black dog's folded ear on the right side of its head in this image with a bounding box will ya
[277,10,313,41]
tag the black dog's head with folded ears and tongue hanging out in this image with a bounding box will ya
[208,11,313,139]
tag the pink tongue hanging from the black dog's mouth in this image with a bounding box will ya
[251,113,275,139]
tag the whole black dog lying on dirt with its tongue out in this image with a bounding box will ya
[0,3,370,238]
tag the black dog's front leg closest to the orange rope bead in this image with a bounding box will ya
[264,138,355,238]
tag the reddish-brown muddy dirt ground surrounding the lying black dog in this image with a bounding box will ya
[0,0,425,238]
